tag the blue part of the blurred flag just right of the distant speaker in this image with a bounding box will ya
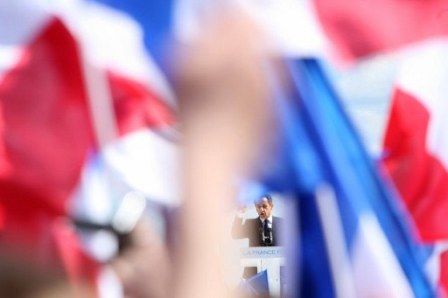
[265,59,434,297]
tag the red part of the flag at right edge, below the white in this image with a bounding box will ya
[384,90,448,242]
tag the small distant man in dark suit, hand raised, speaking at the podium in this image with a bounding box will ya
[232,195,283,278]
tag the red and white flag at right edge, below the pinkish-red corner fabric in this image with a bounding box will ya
[384,41,448,291]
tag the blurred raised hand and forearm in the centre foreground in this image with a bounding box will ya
[175,8,269,298]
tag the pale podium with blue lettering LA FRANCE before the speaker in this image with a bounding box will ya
[240,246,285,297]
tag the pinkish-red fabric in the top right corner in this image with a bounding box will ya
[314,0,448,59]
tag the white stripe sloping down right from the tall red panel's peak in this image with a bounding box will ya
[55,0,176,107]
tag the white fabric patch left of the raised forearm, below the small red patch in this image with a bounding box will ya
[72,129,179,223]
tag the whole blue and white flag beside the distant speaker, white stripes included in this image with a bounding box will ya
[260,60,434,297]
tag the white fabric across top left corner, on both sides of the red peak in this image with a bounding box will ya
[0,0,176,106]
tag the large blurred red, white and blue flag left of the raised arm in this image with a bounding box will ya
[0,0,178,297]
